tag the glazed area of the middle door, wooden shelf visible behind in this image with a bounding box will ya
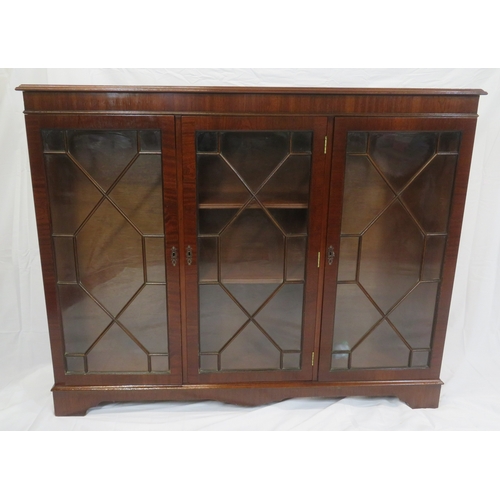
[197,131,312,371]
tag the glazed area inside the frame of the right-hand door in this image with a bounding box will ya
[331,131,460,370]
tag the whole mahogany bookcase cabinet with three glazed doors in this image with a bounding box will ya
[19,85,484,415]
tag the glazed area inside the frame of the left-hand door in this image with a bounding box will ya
[42,130,169,373]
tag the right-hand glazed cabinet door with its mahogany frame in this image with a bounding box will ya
[319,118,475,380]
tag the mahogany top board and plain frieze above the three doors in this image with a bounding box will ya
[18,86,482,116]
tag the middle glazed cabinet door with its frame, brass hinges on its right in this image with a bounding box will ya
[182,117,327,383]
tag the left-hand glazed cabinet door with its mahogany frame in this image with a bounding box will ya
[28,116,181,384]
